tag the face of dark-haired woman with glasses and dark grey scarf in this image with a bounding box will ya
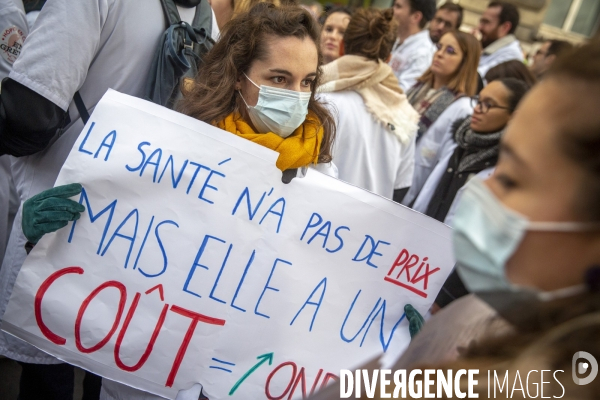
[471,81,511,133]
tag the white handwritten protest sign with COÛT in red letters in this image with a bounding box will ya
[2,91,453,399]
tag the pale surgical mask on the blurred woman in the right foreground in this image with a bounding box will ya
[452,178,599,292]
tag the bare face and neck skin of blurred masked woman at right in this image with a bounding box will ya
[486,79,600,291]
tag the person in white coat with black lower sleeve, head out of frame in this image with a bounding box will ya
[0,0,218,400]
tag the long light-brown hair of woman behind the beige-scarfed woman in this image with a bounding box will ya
[417,31,481,96]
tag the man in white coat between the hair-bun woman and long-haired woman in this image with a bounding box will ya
[390,0,436,92]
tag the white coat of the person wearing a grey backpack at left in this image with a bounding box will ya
[0,0,218,399]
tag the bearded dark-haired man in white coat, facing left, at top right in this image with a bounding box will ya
[477,1,524,76]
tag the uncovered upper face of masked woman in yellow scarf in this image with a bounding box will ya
[235,36,319,122]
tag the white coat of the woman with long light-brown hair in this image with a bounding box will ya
[402,97,473,208]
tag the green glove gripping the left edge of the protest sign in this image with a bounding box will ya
[22,183,85,244]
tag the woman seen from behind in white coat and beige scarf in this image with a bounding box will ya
[319,9,419,199]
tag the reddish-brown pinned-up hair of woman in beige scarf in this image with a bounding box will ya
[344,9,398,61]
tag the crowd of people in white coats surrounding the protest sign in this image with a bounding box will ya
[0,0,600,400]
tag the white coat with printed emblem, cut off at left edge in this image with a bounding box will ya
[0,0,29,264]
